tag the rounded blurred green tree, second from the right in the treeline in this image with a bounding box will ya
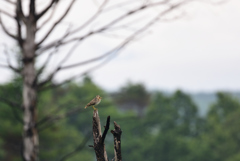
[141,91,199,161]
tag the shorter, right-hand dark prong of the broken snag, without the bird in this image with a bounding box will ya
[111,121,122,161]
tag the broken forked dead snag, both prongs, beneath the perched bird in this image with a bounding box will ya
[91,110,122,161]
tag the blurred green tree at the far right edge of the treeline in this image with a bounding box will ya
[202,93,240,161]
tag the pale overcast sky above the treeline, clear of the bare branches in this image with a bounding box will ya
[0,0,240,92]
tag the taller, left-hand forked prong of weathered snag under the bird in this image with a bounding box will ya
[93,110,110,161]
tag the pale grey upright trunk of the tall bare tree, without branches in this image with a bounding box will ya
[22,4,39,161]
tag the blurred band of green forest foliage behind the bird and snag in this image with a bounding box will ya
[0,77,240,161]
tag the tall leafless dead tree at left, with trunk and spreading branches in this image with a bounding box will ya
[0,0,225,161]
